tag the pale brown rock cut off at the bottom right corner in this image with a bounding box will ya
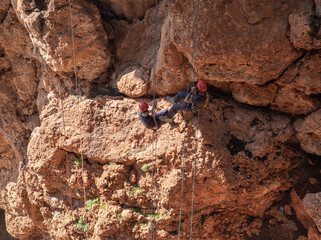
[303,193,321,232]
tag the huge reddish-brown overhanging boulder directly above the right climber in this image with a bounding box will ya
[172,0,304,84]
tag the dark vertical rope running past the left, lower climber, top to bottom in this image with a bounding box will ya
[151,0,158,240]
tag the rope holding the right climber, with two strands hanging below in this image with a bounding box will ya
[177,0,199,240]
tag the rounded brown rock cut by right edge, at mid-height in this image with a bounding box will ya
[294,110,321,156]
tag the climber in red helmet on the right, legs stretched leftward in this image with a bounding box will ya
[159,80,209,123]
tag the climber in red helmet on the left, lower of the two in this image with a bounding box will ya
[138,101,178,130]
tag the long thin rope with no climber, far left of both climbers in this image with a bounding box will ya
[68,0,88,239]
